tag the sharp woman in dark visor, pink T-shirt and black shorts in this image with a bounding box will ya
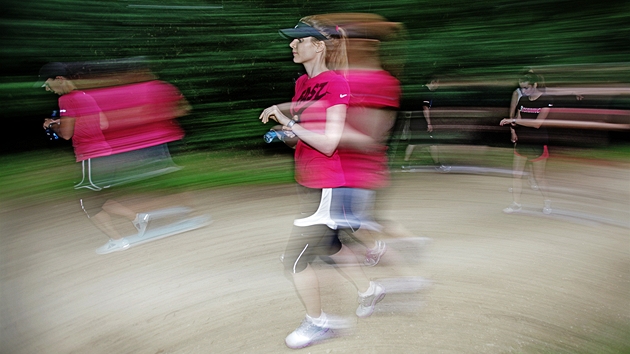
[260,16,382,348]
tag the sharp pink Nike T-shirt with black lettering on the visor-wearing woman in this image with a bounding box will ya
[291,71,350,188]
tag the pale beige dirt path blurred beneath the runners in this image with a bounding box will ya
[0,156,630,354]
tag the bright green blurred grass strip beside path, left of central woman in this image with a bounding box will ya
[0,150,293,207]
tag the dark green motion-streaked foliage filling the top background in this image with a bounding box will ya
[0,0,630,151]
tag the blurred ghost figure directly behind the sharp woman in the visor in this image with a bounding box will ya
[335,14,401,266]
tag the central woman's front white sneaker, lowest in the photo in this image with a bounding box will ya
[284,313,350,349]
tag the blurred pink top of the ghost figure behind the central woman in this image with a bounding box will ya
[339,70,401,189]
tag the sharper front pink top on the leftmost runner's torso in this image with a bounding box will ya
[59,91,112,162]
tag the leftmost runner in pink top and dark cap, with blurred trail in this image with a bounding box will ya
[39,63,187,254]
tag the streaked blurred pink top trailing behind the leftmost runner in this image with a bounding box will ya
[87,80,184,154]
